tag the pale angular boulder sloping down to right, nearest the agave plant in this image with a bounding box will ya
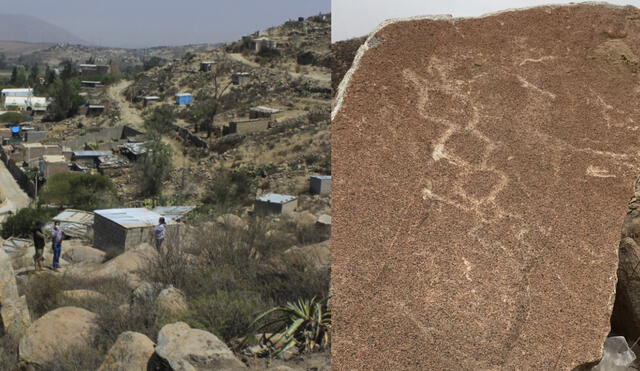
[156,322,246,371]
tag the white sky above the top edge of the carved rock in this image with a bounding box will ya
[331,0,640,42]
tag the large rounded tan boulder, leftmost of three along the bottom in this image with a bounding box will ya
[19,307,98,365]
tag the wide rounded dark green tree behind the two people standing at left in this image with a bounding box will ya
[39,172,116,211]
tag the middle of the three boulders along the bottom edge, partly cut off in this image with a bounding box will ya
[98,331,154,371]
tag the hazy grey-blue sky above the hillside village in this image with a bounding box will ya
[0,0,331,47]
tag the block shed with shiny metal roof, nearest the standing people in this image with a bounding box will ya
[93,208,176,251]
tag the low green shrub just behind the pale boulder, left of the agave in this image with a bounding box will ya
[185,290,265,341]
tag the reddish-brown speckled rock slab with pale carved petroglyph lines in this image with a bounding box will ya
[332,5,640,370]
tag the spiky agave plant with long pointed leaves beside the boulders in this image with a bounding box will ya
[251,297,331,356]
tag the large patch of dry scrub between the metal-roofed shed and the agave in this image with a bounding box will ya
[143,218,329,341]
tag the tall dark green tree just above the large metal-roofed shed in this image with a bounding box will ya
[136,138,172,196]
